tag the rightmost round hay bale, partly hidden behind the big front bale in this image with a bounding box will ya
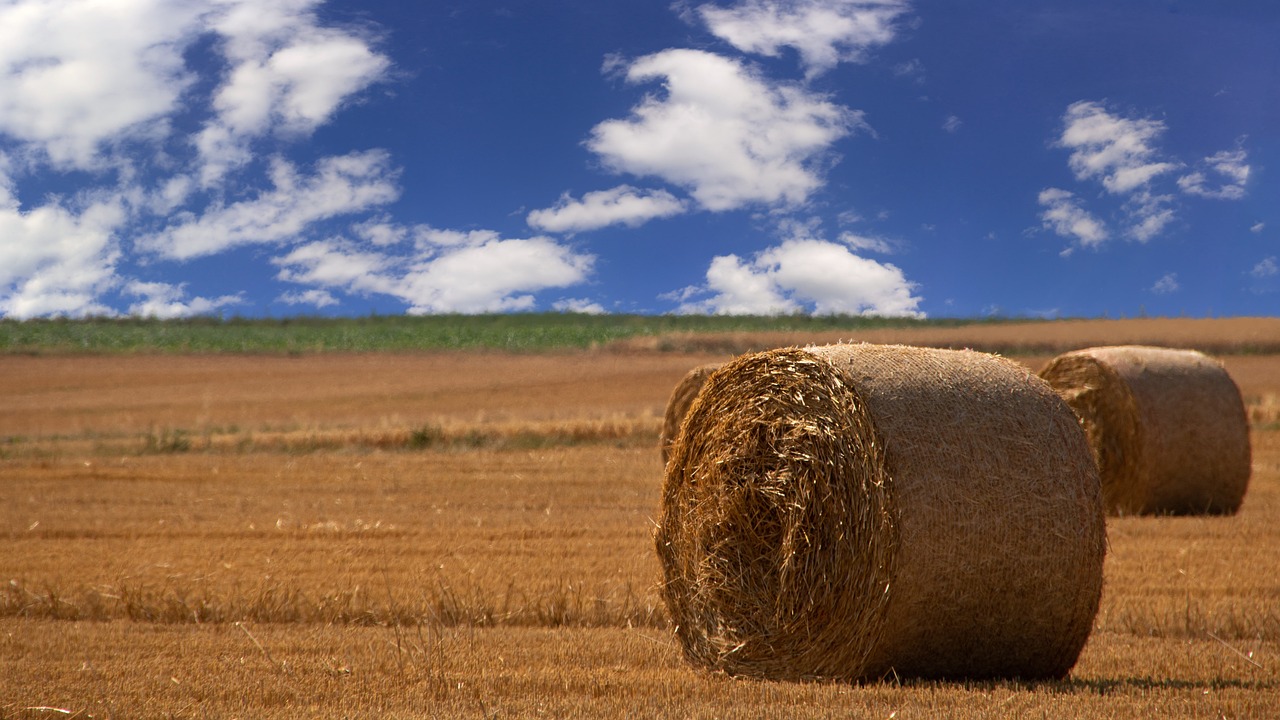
[1041,346,1251,515]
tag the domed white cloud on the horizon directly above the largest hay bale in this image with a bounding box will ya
[680,238,923,316]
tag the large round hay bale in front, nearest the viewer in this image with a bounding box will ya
[655,345,1106,679]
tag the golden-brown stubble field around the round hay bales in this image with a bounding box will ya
[0,322,1280,717]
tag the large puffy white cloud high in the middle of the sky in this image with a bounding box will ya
[588,50,869,211]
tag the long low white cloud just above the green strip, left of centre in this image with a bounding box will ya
[274,228,595,314]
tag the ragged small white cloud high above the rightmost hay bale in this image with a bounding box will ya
[1059,100,1178,195]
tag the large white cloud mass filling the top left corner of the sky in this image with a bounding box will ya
[0,0,390,178]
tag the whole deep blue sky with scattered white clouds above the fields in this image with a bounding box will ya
[0,0,1280,318]
